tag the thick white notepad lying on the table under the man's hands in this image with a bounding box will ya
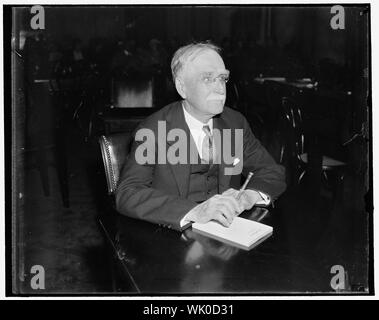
[192,217,273,250]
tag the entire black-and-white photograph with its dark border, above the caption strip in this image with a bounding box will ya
[3,3,374,298]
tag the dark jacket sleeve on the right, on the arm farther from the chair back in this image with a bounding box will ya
[243,118,286,200]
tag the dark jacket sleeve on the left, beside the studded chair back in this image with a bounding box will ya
[116,132,197,230]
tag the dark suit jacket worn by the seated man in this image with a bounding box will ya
[116,102,285,230]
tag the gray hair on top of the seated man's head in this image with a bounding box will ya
[171,42,221,83]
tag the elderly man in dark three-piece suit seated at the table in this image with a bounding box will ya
[116,43,285,230]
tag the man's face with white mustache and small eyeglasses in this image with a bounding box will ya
[182,50,229,121]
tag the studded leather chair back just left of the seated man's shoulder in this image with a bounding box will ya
[99,132,132,195]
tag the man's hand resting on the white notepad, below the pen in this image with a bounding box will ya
[186,194,243,227]
